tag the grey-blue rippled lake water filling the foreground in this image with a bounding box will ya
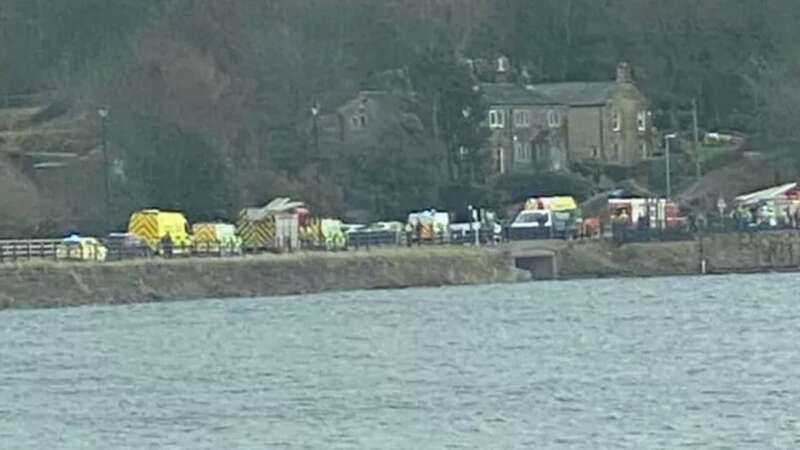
[0,275,800,449]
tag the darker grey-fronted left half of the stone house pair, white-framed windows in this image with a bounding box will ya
[477,58,568,174]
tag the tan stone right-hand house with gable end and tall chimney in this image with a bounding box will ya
[527,63,656,167]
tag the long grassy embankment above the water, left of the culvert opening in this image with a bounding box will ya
[0,247,514,309]
